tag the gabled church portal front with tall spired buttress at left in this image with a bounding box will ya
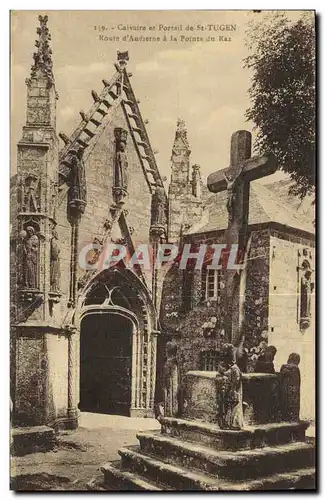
[11,17,167,427]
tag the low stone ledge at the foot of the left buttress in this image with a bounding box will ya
[11,425,56,456]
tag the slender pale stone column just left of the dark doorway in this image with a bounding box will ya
[66,325,78,429]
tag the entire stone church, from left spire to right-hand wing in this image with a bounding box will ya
[11,16,315,428]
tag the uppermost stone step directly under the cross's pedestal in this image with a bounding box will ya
[159,417,309,451]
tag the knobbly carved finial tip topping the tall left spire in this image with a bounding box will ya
[31,16,54,84]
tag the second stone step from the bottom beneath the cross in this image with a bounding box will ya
[137,431,315,479]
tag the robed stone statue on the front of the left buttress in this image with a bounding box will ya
[23,226,39,290]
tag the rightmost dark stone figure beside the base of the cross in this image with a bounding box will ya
[280,352,300,422]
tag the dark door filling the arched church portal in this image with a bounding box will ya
[80,311,134,416]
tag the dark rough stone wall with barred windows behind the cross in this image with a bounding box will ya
[161,230,269,384]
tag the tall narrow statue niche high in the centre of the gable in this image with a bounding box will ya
[113,127,129,203]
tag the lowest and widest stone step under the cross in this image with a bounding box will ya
[119,448,315,491]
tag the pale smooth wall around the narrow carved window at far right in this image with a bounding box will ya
[269,231,315,420]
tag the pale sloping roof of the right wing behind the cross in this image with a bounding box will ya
[186,180,315,234]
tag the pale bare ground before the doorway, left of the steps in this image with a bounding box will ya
[11,413,160,491]
